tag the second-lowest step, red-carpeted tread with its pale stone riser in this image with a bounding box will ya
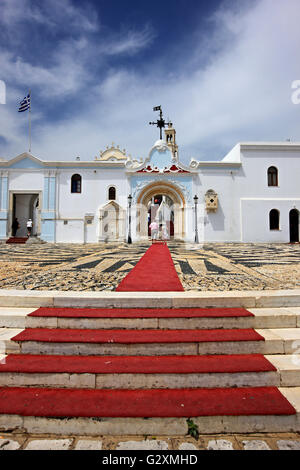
[0,354,280,389]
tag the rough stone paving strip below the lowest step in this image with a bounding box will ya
[0,433,300,451]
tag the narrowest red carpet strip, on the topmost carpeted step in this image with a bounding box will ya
[29,307,254,318]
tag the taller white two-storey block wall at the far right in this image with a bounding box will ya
[239,148,300,243]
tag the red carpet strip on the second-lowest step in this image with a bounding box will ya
[0,354,276,374]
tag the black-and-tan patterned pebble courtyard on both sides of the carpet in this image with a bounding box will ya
[0,242,300,291]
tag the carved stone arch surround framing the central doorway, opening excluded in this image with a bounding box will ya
[136,181,186,240]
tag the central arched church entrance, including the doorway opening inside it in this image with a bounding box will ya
[136,182,185,240]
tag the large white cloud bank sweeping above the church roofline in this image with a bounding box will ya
[0,0,300,161]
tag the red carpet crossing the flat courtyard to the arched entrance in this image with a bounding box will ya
[116,243,184,292]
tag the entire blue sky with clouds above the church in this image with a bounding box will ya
[0,0,300,163]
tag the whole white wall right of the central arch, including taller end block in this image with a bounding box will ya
[195,145,300,242]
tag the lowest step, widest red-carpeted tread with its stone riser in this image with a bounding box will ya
[0,387,300,436]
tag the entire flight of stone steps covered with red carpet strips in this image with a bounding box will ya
[0,300,300,435]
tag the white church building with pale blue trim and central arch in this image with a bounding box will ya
[0,120,300,243]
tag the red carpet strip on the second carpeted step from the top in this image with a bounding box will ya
[12,328,264,344]
